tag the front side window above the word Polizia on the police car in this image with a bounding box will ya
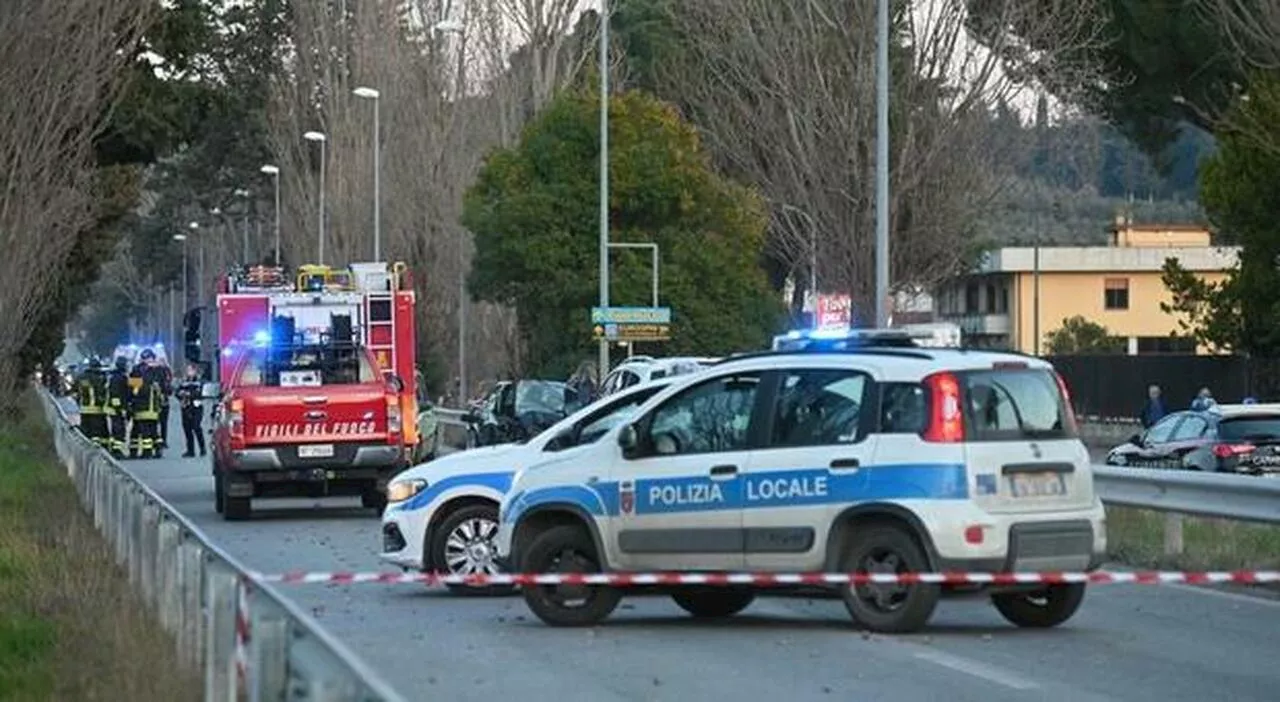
[648,373,760,456]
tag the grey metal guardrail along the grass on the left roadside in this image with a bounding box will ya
[40,392,404,702]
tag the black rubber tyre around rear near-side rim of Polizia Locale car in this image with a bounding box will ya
[840,524,942,634]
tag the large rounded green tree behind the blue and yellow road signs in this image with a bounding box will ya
[462,91,782,375]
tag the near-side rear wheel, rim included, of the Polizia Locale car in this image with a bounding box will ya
[840,524,942,633]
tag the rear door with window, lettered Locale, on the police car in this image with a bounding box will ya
[742,364,878,570]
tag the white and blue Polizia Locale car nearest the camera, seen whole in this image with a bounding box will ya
[497,339,1106,632]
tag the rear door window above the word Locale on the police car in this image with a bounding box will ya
[769,369,867,448]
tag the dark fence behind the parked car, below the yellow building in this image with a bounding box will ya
[1046,355,1280,416]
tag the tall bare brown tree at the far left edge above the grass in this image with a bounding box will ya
[0,0,154,397]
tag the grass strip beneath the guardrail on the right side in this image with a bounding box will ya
[1107,506,1280,570]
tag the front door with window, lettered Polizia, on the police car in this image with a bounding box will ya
[612,371,760,570]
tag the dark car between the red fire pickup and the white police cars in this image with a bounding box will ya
[462,380,582,448]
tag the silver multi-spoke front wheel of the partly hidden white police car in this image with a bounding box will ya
[426,505,513,594]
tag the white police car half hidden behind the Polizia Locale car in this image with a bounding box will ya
[380,379,669,589]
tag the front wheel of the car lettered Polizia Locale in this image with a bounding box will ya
[522,525,622,626]
